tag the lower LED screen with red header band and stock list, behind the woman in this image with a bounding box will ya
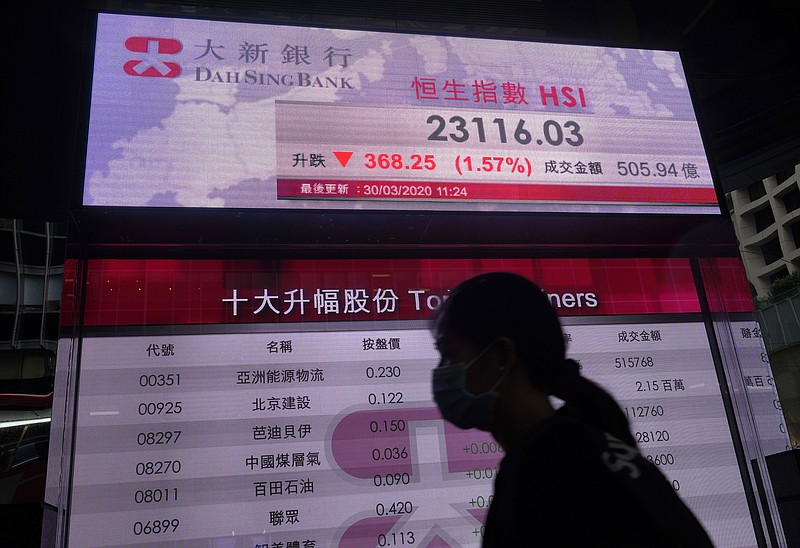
[68,259,756,548]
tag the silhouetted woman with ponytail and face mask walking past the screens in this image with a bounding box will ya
[433,273,712,548]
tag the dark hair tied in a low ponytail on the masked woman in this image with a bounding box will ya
[435,272,636,446]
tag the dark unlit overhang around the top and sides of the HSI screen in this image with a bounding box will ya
[6,0,800,220]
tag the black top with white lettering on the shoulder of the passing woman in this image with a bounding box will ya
[483,406,712,548]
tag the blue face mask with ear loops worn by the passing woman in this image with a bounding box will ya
[432,343,506,432]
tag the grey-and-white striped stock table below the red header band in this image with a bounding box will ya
[65,316,752,548]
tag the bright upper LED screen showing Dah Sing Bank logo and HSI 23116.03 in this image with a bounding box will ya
[83,14,719,213]
